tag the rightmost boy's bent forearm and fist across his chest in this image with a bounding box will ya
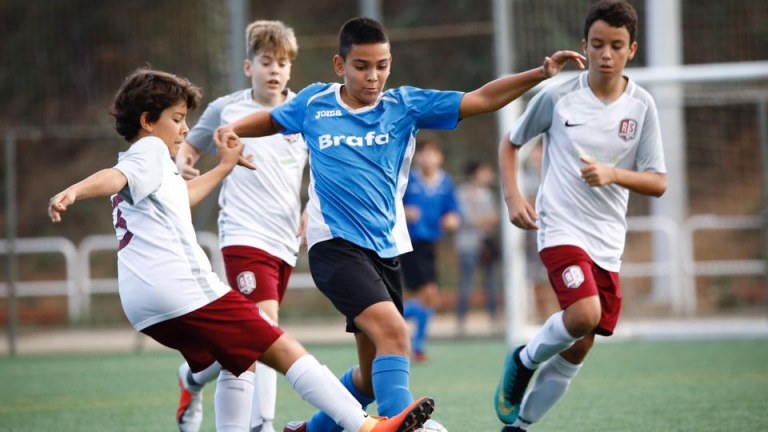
[579,156,667,197]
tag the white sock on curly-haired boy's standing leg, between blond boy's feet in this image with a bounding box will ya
[213,370,254,432]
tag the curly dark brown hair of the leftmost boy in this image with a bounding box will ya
[110,68,202,142]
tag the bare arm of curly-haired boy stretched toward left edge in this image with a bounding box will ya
[48,168,128,223]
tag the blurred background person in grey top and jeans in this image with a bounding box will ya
[454,161,499,335]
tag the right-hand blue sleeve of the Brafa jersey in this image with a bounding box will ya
[396,87,464,129]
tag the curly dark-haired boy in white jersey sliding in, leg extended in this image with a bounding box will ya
[48,66,433,432]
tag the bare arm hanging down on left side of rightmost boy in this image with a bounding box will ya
[499,134,539,229]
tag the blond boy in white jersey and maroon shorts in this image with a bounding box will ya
[176,21,308,432]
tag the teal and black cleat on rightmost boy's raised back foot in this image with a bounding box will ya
[493,345,534,424]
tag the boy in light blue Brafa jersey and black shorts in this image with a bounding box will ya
[219,18,584,432]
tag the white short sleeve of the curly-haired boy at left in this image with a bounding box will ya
[114,137,169,205]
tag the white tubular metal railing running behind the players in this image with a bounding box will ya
[0,215,765,321]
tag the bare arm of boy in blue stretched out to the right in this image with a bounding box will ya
[459,51,586,118]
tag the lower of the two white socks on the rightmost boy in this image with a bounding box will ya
[518,355,581,429]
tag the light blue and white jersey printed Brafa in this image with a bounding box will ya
[271,83,463,258]
